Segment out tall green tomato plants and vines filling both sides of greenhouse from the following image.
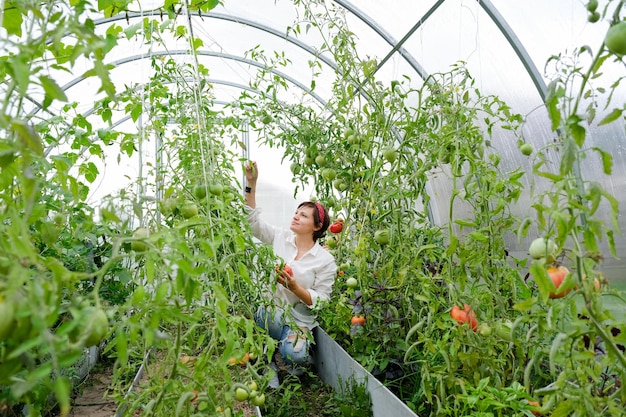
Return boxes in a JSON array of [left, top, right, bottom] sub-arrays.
[[0, 0, 626, 416]]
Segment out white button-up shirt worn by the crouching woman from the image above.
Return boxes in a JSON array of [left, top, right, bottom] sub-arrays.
[[245, 206, 337, 329]]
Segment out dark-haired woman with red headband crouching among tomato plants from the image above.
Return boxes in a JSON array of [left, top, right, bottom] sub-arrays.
[[245, 162, 337, 370]]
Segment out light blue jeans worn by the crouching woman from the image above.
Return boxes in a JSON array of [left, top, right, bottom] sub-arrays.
[[254, 306, 311, 364]]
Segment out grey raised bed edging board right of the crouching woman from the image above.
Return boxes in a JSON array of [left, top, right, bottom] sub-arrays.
[[313, 326, 418, 417]]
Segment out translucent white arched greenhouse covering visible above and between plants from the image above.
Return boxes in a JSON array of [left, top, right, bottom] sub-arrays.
[[3, 0, 626, 280]]
